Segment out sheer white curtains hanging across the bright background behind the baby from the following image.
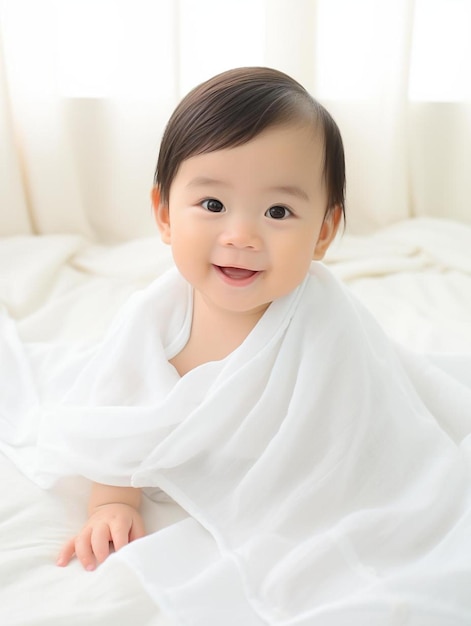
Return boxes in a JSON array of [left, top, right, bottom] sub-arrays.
[[0, 0, 471, 242]]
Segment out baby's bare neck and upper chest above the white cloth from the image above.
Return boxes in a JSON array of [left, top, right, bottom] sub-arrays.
[[171, 295, 264, 376]]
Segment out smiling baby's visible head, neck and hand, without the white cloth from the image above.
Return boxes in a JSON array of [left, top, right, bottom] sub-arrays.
[[57, 67, 345, 570]]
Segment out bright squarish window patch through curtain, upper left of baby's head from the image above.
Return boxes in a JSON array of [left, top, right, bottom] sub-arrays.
[[54, 0, 175, 99]]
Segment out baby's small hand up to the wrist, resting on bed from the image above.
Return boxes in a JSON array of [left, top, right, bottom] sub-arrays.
[[57, 502, 145, 571]]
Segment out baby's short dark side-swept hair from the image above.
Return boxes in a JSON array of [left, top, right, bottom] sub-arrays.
[[154, 67, 345, 217]]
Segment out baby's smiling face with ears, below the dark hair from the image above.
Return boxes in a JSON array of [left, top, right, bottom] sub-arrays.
[[159, 125, 338, 324]]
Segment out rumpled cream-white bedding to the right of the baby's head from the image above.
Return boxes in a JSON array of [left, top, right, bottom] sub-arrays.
[[328, 218, 471, 354]]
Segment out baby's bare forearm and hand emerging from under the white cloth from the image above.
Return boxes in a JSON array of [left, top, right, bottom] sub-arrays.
[[57, 483, 145, 571]]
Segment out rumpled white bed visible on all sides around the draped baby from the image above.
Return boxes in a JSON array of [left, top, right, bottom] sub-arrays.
[[0, 218, 471, 626]]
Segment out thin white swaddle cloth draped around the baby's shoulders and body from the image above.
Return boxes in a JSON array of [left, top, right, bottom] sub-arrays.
[[1, 263, 471, 626]]
